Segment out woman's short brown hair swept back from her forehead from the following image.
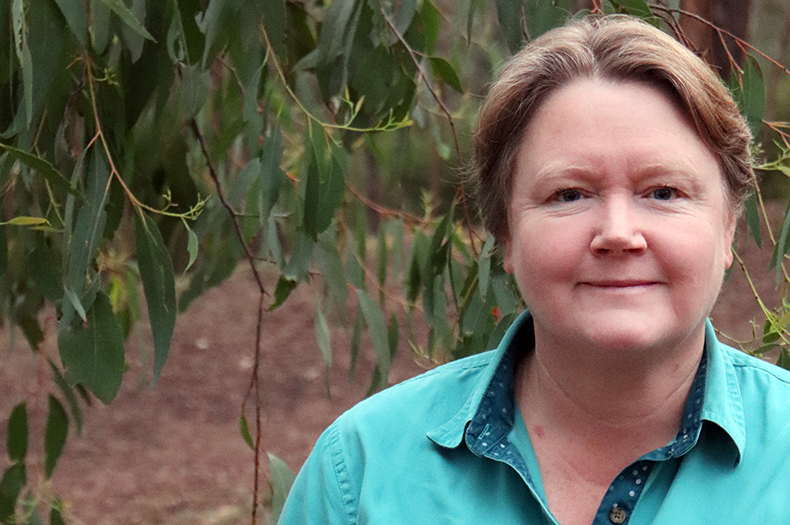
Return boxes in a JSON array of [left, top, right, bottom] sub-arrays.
[[471, 15, 755, 241]]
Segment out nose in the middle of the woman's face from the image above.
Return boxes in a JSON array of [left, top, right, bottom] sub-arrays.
[[590, 195, 647, 255]]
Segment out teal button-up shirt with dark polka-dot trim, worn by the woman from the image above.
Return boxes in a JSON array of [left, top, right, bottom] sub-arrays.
[[279, 313, 790, 525]]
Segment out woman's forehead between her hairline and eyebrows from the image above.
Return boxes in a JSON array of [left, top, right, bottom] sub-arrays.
[[516, 79, 723, 188]]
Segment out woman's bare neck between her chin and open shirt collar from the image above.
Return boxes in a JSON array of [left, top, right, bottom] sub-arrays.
[[516, 327, 705, 461]]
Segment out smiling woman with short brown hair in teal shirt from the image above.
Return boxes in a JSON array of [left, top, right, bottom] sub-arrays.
[[281, 17, 790, 525]]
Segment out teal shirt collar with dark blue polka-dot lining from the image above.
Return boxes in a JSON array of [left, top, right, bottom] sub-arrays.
[[428, 311, 746, 465]]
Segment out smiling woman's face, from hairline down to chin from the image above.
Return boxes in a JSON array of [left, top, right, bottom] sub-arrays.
[[505, 80, 735, 350]]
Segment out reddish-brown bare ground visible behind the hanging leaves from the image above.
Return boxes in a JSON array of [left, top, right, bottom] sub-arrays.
[[0, 205, 781, 525]]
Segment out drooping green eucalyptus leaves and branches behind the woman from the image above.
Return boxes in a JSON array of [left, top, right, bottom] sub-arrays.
[[0, 0, 790, 523]]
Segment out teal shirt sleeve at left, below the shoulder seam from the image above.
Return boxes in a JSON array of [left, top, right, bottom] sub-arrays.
[[278, 421, 357, 525]]
